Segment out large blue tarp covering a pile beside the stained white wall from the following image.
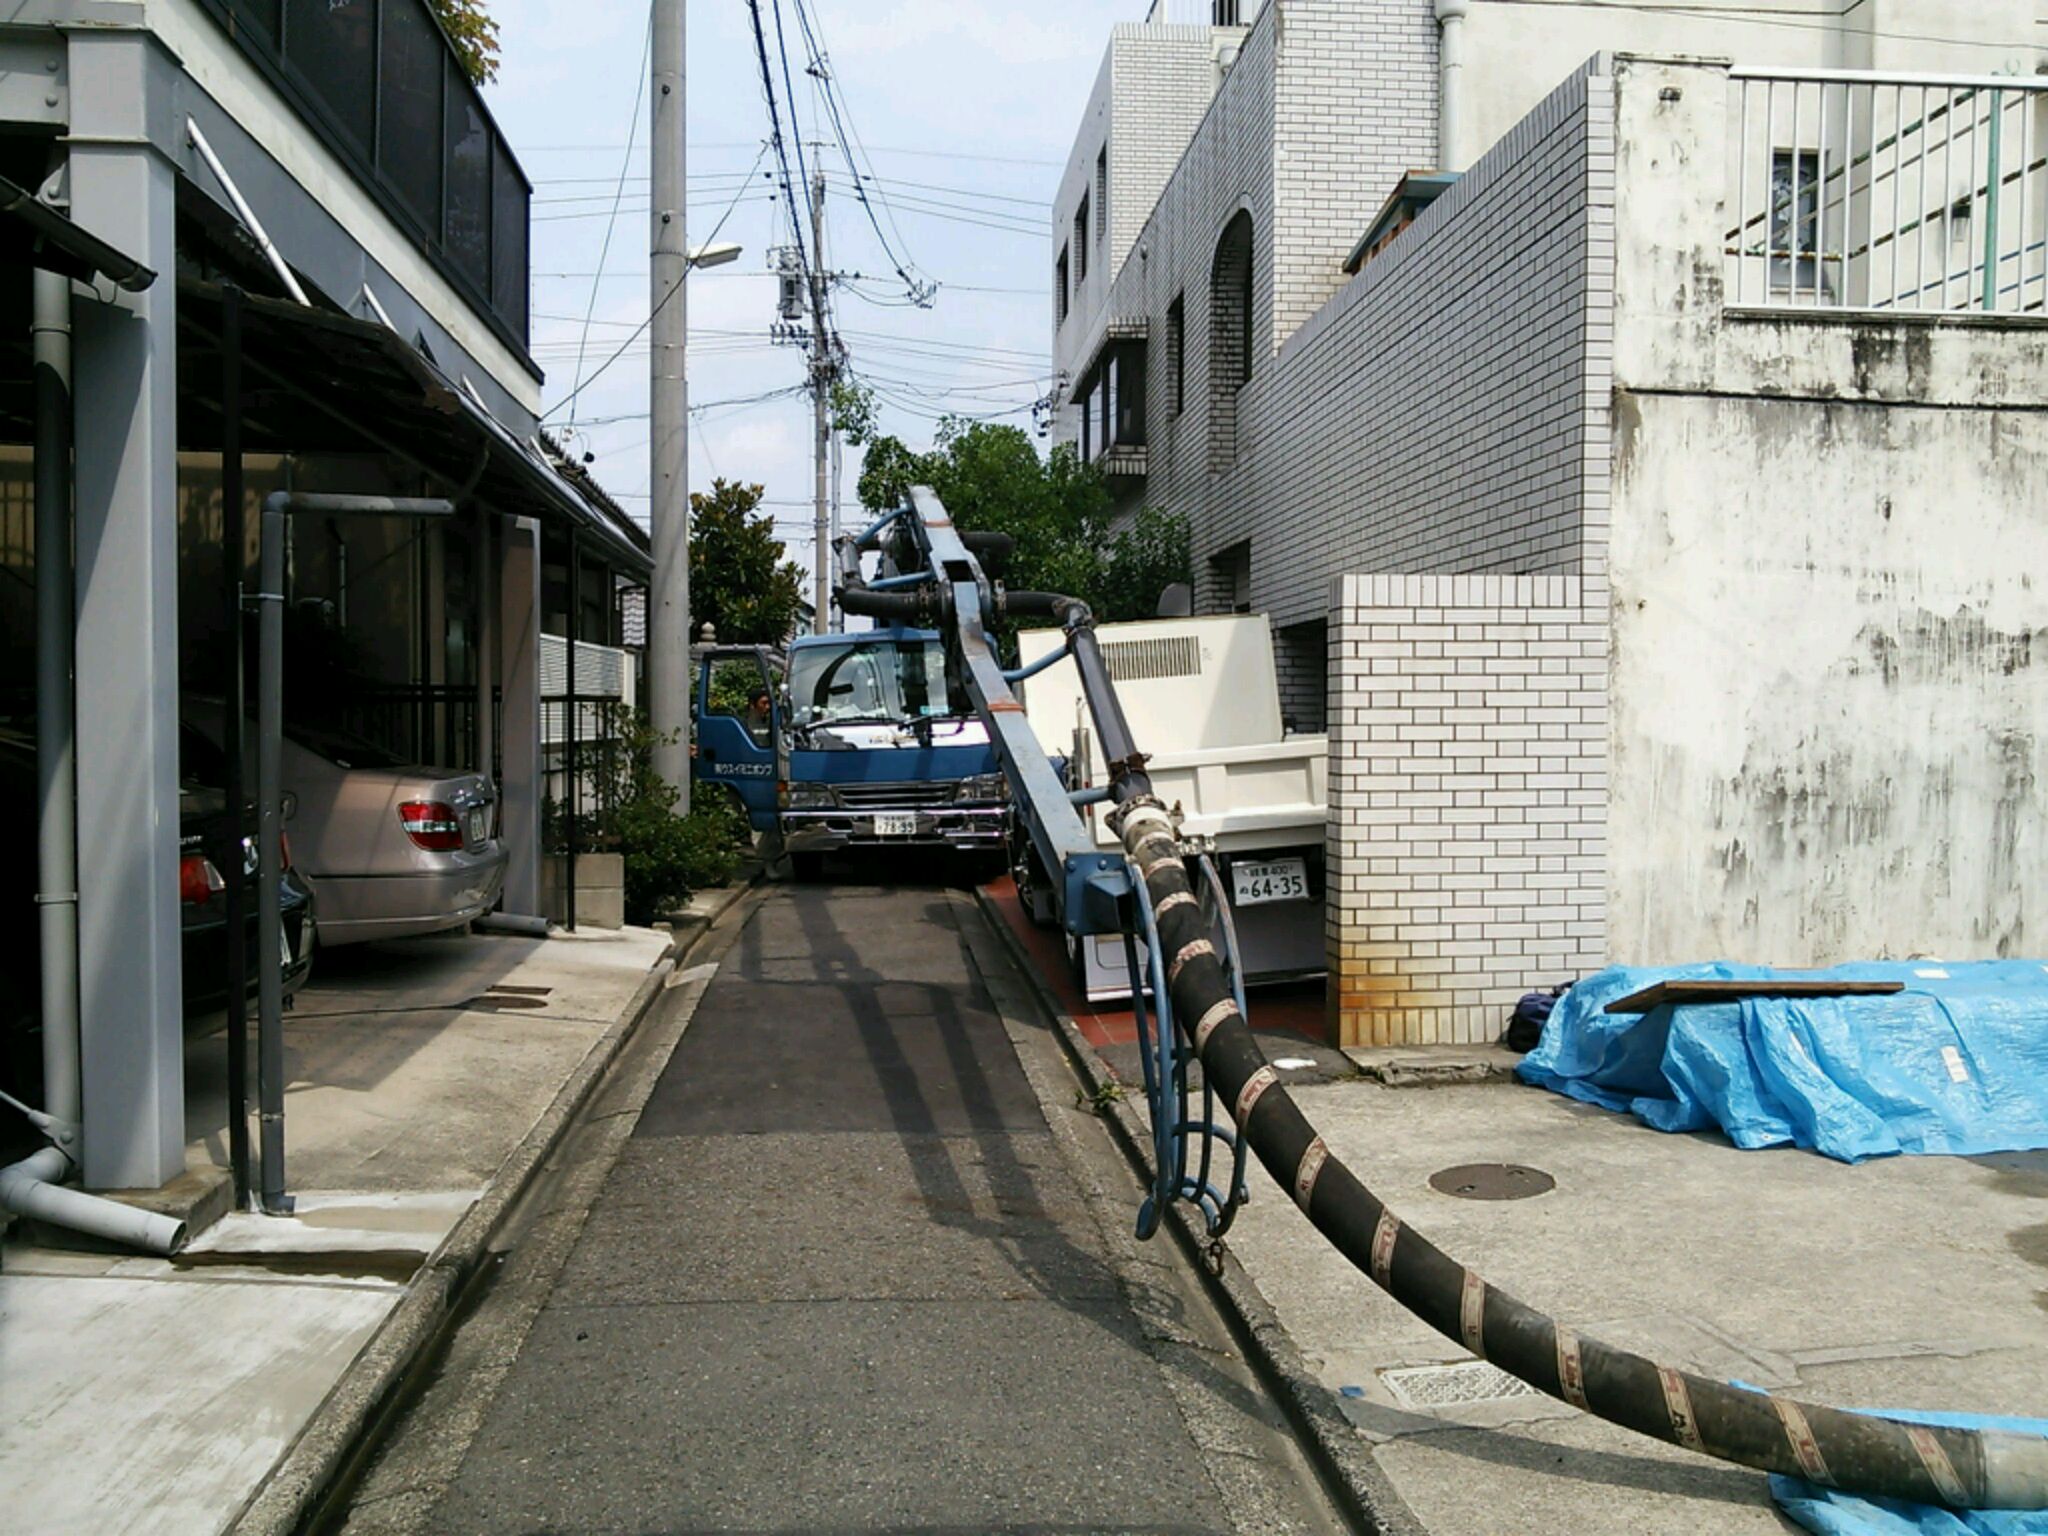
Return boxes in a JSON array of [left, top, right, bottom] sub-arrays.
[[1518, 961, 2048, 1163]]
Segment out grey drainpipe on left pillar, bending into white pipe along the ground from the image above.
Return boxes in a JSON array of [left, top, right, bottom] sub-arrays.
[[0, 268, 184, 1253]]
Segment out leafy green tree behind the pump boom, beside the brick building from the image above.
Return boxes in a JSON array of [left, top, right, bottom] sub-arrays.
[[858, 418, 1190, 623]]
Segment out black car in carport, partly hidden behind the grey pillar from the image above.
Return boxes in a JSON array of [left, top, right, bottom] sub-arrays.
[[0, 731, 315, 1102]]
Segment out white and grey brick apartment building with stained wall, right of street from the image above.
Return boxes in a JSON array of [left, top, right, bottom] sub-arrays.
[[1053, 0, 2048, 1040]]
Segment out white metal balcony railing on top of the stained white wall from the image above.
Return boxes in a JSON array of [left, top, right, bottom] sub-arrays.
[[1726, 70, 2048, 315]]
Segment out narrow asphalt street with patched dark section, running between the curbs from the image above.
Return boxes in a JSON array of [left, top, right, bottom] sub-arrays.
[[346, 885, 1343, 1532]]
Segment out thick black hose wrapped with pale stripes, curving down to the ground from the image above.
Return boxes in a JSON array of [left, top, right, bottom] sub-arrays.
[[1116, 793, 2048, 1509]]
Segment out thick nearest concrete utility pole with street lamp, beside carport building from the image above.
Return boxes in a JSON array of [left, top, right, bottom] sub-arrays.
[[647, 0, 690, 813]]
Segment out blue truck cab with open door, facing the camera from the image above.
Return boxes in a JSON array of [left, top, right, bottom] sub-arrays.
[[694, 627, 1010, 881]]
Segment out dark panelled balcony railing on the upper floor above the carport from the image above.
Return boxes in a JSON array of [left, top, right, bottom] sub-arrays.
[[201, 0, 532, 352]]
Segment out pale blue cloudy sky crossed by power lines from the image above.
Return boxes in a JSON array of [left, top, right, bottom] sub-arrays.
[[485, 0, 1147, 565]]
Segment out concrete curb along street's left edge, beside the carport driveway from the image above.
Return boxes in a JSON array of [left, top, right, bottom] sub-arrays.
[[227, 933, 684, 1536]]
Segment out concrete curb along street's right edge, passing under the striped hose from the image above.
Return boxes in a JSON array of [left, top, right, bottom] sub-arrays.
[[975, 887, 1427, 1536]]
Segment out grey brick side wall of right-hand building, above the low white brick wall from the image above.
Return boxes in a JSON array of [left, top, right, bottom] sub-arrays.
[[1063, 0, 1614, 629]]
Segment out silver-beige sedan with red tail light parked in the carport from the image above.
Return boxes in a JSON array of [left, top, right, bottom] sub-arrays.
[[184, 700, 506, 948]]
